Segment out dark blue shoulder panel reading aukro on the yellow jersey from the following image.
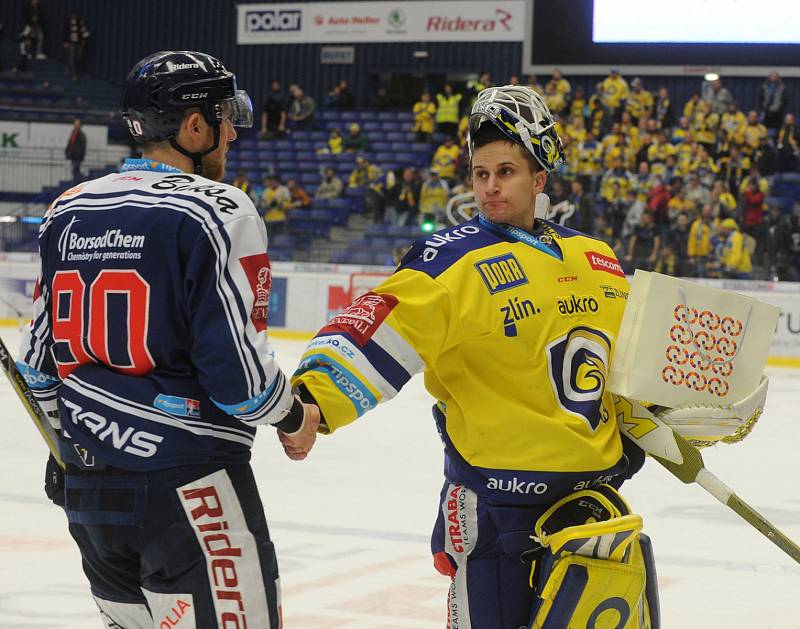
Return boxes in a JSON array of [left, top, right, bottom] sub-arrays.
[[398, 219, 510, 278]]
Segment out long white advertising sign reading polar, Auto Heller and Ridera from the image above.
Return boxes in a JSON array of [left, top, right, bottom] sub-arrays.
[[236, 0, 527, 44]]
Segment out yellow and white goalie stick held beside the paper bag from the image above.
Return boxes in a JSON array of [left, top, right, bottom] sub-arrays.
[[614, 395, 800, 563]]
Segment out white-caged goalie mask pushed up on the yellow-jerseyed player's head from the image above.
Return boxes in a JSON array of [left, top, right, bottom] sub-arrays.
[[467, 85, 565, 172]]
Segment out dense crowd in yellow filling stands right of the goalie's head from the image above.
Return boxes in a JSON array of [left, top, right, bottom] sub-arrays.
[[543, 70, 800, 280]]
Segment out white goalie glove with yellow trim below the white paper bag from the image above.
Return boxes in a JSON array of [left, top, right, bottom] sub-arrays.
[[650, 376, 769, 447]]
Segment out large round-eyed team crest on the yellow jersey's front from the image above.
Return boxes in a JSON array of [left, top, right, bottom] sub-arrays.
[[546, 326, 611, 430]]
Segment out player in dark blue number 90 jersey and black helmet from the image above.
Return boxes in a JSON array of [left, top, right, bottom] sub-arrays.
[[18, 52, 319, 629]]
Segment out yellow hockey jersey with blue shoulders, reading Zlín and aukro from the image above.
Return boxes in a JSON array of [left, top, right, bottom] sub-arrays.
[[292, 215, 628, 504]]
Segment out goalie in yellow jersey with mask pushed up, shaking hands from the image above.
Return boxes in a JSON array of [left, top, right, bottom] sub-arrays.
[[290, 86, 658, 629]]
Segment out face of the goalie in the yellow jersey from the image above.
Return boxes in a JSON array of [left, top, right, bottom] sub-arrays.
[[472, 141, 547, 229]]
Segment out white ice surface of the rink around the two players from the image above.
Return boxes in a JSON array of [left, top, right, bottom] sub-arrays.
[[0, 328, 800, 629]]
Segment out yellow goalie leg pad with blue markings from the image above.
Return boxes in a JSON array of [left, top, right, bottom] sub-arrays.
[[529, 485, 658, 629]]
